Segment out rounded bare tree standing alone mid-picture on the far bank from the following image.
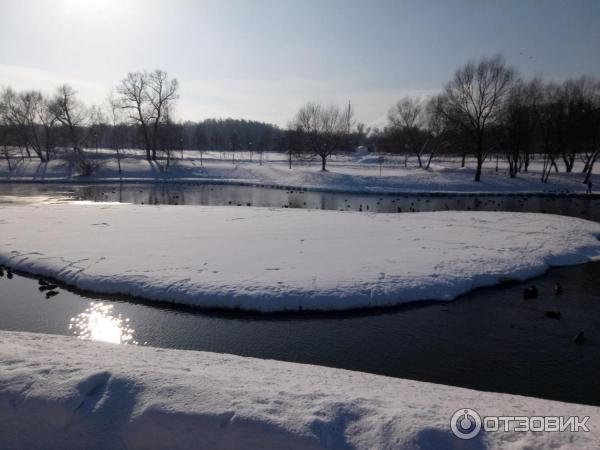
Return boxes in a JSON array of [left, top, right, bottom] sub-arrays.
[[290, 102, 353, 171]]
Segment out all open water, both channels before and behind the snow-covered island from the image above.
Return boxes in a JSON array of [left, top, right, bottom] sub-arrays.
[[0, 184, 600, 405]]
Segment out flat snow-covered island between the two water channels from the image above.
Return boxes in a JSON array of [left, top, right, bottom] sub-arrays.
[[0, 203, 600, 311]]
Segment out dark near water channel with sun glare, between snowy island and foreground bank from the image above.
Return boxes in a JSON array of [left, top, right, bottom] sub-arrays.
[[0, 263, 600, 405]]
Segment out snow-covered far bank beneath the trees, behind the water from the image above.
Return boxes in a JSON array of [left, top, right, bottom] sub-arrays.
[[0, 151, 600, 193]]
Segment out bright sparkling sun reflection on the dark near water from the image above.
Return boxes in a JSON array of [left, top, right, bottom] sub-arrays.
[[69, 302, 137, 344]]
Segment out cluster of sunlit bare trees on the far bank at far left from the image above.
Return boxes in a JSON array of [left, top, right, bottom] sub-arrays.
[[0, 70, 178, 172]]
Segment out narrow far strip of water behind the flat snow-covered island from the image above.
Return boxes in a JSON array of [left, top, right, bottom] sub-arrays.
[[0, 183, 600, 221]]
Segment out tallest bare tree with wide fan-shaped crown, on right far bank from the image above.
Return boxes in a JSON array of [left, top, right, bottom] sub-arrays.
[[444, 55, 515, 181]]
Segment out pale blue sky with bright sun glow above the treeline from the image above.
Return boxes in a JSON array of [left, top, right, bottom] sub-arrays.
[[0, 0, 600, 126]]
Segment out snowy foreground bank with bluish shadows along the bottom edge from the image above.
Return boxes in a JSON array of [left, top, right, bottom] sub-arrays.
[[0, 332, 600, 450]]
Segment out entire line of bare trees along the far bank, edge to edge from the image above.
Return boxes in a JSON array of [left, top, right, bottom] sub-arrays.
[[0, 56, 600, 182]]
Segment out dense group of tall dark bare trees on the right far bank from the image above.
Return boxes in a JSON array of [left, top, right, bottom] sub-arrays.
[[372, 56, 600, 182]]
